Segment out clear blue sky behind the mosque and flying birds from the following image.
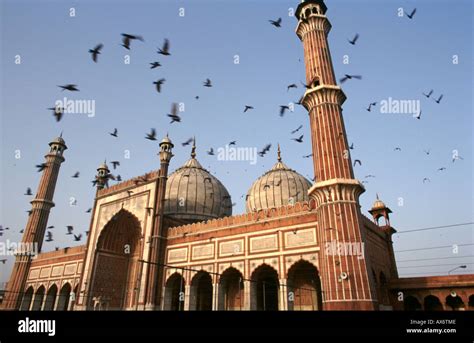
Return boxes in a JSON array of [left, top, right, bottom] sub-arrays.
[[0, 0, 474, 282]]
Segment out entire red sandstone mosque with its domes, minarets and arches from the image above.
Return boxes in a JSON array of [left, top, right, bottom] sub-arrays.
[[2, 0, 474, 310]]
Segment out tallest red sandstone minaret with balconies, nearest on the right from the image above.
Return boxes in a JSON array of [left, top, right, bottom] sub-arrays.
[[295, 0, 376, 310]]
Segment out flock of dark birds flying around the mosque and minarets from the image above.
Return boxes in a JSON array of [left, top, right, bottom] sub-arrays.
[[0, 8, 462, 255]]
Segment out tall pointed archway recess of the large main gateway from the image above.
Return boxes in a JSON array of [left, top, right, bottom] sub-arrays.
[[89, 209, 141, 310]]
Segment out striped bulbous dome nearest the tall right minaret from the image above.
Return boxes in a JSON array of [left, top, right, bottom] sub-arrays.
[[246, 146, 311, 212]]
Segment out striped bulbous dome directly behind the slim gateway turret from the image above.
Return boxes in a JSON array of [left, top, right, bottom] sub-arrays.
[[164, 143, 232, 222]]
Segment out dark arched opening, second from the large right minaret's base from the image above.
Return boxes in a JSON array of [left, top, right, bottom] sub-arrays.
[[250, 264, 279, 311]]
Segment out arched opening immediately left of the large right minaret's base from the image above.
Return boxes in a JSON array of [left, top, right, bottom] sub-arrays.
[[287, 260, 322, 311]]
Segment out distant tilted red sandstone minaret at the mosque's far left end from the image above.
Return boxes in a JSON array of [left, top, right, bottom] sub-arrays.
[[4, 136, 67, 310]]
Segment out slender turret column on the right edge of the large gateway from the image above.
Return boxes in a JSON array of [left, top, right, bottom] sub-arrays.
[[145, 135, 174, 310]]
